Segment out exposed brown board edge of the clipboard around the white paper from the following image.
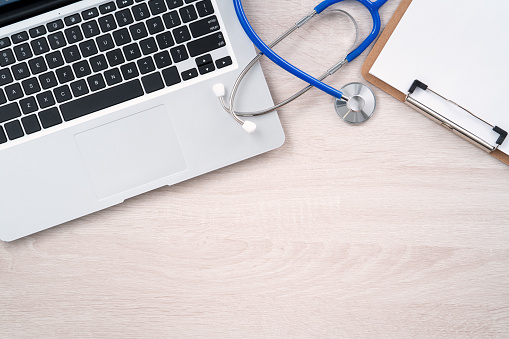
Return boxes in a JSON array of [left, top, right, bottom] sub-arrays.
[[361, 0, 509, 165]]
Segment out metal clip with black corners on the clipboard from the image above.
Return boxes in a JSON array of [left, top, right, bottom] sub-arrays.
[[405, 80, 507, 153]]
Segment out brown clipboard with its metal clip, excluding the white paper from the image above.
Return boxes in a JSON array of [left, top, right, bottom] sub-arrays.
[[361, 0, 509, 165]]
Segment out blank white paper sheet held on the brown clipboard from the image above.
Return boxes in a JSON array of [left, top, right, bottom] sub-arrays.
[[370, 0, 509, 154]]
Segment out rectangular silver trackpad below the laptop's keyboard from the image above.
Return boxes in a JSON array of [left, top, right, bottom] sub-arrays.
[[75, 105, 187, 199]]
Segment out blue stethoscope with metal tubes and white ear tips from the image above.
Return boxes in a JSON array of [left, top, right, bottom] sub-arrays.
[[213, 0, 387, 133]]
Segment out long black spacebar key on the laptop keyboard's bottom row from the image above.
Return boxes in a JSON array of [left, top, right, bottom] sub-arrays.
[[60, 79, 143, 121]]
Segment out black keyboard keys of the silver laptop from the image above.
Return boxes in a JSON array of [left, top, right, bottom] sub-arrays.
[[0, 0, 232, 144]]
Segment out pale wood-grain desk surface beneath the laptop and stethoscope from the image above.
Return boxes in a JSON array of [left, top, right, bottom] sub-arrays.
[[0, 0, 509, 338]]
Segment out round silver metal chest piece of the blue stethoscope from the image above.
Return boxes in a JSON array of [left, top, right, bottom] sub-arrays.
[[334, 82, 376, 125]]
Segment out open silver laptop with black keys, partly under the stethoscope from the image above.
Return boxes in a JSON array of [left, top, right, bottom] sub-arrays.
[[0, 0, 284, 241]]
